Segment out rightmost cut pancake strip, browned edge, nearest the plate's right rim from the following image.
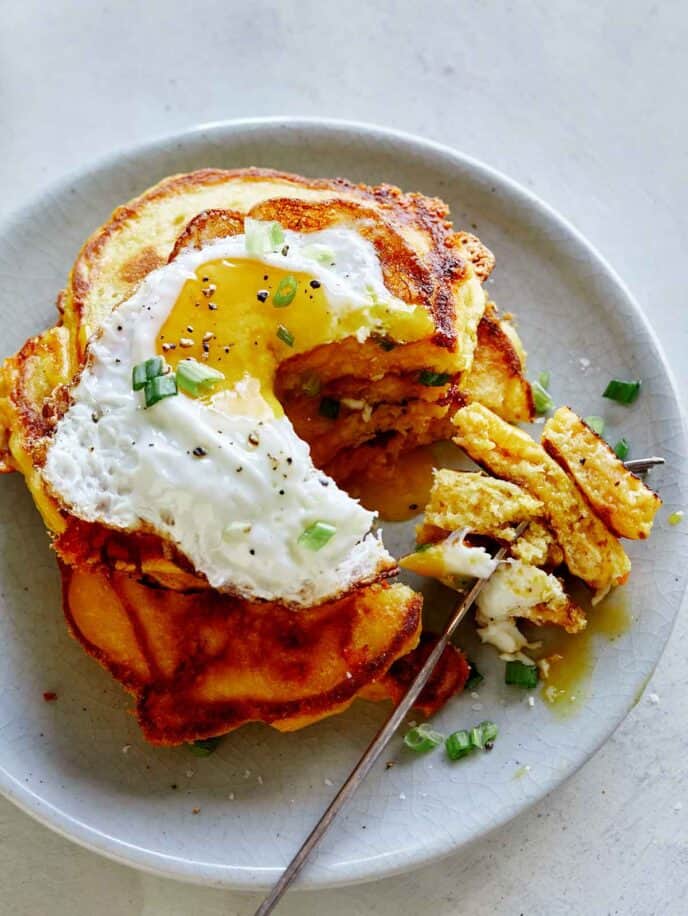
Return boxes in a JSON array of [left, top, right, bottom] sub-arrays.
[[542, 407, 662, 539]]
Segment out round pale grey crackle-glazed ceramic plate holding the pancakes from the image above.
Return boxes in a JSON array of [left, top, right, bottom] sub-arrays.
[[0, 119, 688, 888]]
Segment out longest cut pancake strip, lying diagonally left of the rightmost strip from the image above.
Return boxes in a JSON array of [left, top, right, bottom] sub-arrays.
[[452, 404, 631, 592]]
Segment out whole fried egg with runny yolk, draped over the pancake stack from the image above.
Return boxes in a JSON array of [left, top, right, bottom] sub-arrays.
[[42, 220, 431, 607]]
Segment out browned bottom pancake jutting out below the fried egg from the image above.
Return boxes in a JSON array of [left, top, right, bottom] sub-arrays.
[[62, 567, 430, 744]]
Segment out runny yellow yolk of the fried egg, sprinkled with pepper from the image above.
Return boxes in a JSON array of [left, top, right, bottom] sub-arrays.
[[157, 258, 432, 417]]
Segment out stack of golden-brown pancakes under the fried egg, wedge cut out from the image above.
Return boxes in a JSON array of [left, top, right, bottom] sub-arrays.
[[0, 169, 533, 744]]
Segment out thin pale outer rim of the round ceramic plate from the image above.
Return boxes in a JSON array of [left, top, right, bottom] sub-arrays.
[[0, 115, 688, 891]]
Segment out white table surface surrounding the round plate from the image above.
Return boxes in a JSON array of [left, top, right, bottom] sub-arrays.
[[0, 0, 688, 916]]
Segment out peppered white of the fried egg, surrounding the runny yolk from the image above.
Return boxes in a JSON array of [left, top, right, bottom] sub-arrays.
[[43, 228, 412, 607]]
